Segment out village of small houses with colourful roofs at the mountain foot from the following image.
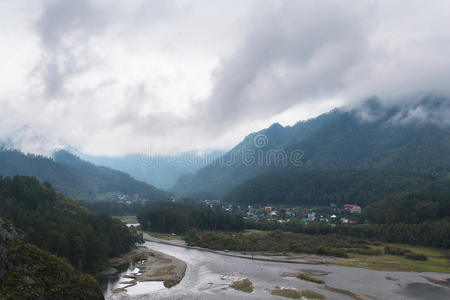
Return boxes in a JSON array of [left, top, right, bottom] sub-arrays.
[[204, 200, 364, 225]]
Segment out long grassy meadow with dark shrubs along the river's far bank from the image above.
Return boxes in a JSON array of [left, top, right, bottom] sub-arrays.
[[184, 231, 450, 273]]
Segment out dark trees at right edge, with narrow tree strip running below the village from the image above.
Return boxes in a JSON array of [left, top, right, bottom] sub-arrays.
[[245, 192, 450, 248]]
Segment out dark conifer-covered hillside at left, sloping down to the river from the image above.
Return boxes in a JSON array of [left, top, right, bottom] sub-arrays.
[[0, 176, 143, 273]]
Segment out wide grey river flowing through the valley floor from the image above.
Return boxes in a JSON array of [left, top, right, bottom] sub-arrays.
[[105, 242, 450, 300]]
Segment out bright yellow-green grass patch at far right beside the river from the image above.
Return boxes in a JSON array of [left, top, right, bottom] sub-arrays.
[[337, 243, 450, 273]]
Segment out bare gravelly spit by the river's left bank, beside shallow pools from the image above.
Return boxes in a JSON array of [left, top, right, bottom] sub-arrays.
[[109, 246, 186, 292]]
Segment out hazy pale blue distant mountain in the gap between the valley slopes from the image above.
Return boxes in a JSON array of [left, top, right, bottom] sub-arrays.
[[80, 150, 225, 189]]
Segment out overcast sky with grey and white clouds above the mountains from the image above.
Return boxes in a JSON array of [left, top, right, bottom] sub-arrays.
[[0, 0, 450, 155]]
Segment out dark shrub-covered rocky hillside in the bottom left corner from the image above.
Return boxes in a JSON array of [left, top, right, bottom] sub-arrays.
[[0, 217, 104, 300]]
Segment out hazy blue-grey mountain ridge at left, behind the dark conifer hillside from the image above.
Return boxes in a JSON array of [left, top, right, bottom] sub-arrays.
[[0, 149, 169, 201]]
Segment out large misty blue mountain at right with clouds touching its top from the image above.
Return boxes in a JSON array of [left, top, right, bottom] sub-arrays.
[[173, 95, 450, 197]]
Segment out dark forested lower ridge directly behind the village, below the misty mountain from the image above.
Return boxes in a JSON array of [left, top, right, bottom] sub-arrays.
[[225, 170, 450, 206]]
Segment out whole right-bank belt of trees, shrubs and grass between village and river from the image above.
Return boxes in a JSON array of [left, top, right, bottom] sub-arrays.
[[137, 193, 450, 273]]
